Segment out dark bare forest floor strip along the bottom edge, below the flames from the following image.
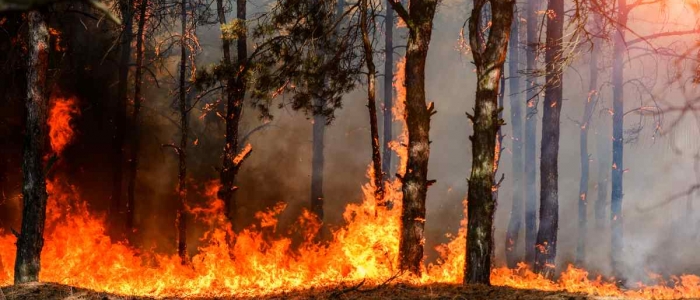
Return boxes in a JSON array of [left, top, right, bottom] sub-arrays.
[[0, 283, 610, 300]]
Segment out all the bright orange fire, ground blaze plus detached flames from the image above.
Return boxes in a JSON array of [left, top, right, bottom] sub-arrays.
[[0, 89, 700, 299]]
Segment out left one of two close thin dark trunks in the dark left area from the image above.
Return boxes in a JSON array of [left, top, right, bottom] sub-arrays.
[[110, 0, 134, 228]]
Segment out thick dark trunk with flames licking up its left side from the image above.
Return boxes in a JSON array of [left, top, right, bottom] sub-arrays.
[[390, 0, 438, 275]]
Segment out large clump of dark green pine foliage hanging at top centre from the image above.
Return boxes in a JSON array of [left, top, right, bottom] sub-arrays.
[[250, 0, 364, 123]]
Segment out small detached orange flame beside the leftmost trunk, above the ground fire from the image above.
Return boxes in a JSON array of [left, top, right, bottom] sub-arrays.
[[48, 98, 80, 155]]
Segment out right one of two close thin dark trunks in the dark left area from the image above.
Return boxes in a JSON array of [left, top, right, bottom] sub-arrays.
[[126, 0, 148, 236]]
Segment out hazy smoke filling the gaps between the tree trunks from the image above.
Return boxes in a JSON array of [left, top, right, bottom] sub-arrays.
[[0, 0, 700, 280]]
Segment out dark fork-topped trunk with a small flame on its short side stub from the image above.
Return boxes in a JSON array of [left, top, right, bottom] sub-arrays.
[[216, 0, 248, 227]]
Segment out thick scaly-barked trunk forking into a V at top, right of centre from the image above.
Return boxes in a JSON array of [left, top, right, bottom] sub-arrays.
[[464, 0, 515, 284]]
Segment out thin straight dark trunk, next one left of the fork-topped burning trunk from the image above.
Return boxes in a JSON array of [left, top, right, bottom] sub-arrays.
[[175, 0, 189, 263]]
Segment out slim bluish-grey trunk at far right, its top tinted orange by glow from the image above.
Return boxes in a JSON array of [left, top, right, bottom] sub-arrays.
[[610, 0, 628, 278]]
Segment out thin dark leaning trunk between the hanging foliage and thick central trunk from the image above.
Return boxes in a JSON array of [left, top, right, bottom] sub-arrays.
[[360, 0, 384, 203]]
